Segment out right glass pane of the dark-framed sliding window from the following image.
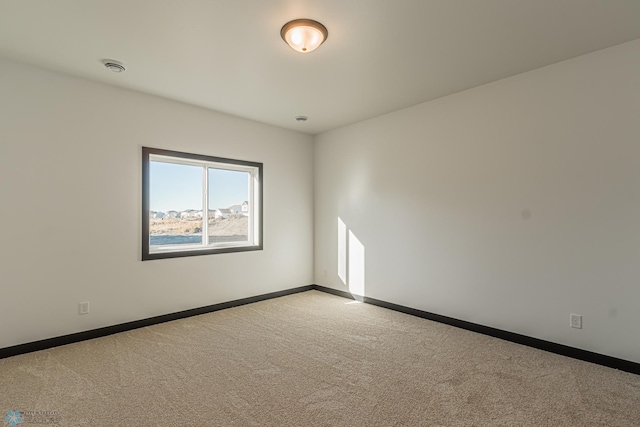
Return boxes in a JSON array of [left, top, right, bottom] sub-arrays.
[[208, 168, 251, 244]]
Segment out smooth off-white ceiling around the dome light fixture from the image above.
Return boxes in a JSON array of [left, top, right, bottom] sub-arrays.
[[0, 0, 640, 134]]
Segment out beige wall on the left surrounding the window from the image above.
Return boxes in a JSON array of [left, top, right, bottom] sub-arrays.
[[0, 61, 313, 348]]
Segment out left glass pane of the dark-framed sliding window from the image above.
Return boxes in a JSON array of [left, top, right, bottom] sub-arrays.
[[149, 161, 203, 250]]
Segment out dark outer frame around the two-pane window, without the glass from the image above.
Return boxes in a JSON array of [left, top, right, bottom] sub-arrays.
[[142, 147, 264, 261]]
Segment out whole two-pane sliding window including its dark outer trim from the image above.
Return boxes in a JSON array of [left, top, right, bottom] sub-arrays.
[[142, 147, 262, 261]]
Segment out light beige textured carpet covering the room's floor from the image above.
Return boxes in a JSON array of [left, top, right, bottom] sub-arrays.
[[0, 291, 640, 427]]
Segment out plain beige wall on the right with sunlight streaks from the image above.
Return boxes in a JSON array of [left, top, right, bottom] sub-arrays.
[[314, 41, 640, 362]]
